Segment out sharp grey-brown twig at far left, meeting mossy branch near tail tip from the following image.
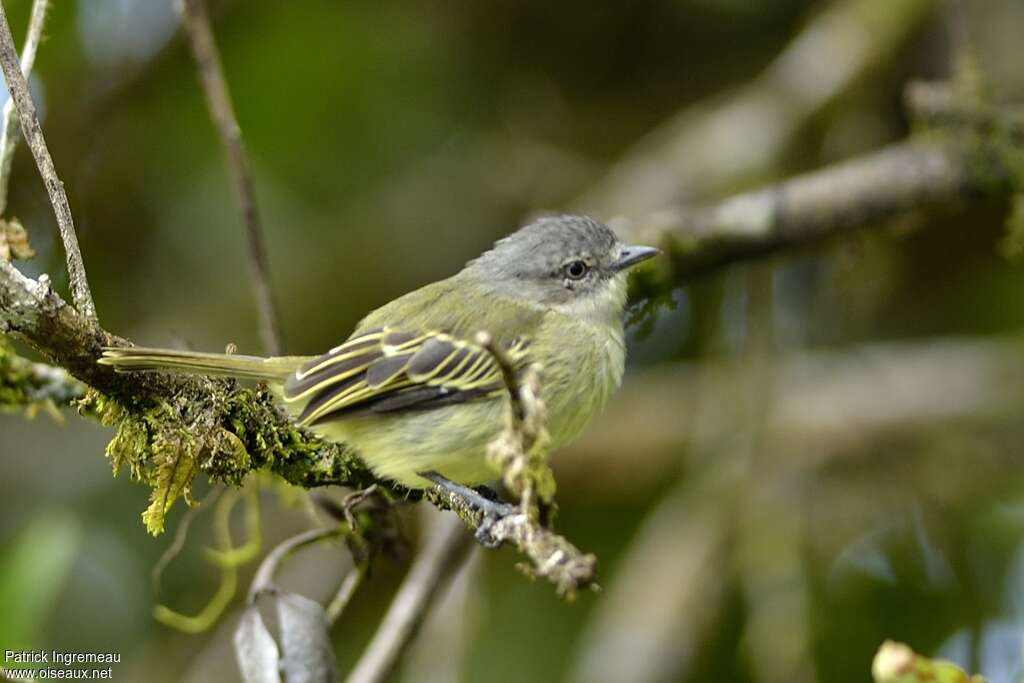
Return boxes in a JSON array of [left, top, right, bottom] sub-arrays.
[[0, 4, 96, 324]]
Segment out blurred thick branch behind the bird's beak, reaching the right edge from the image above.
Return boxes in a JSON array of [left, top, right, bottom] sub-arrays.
[[623, 109, 1024, 283]]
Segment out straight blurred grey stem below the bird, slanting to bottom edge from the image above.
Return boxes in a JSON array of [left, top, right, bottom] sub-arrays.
[[346, 516, 473, 683]]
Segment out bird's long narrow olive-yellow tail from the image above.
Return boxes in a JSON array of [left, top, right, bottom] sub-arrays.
[[97, 346, 308, 382]]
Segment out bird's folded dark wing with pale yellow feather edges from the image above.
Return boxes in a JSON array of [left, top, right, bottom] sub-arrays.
[[284, 328, 528, 426]]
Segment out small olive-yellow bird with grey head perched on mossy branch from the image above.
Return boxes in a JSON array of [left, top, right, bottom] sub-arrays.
[[99, 215, 658, 488]]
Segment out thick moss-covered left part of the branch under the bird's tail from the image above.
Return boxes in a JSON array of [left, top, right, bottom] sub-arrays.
[[0, 255, 376, 533]]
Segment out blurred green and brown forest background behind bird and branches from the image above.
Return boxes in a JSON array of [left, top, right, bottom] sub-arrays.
[[0, 0, 1024, 683]]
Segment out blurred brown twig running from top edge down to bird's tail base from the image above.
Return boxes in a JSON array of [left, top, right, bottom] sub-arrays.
[[180, 0, 285, 355]]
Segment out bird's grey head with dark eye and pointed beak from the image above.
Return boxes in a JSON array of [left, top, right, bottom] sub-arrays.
[[464, 215, 657, 319]]
